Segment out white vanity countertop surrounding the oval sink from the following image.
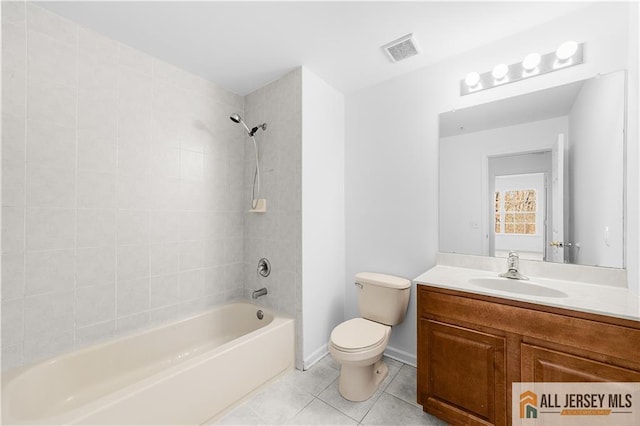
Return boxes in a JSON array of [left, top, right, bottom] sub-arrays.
[[413, 265, 640, 321]]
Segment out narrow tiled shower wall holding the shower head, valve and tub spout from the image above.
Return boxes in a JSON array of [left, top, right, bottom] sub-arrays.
[[243, 68, 302, 368]]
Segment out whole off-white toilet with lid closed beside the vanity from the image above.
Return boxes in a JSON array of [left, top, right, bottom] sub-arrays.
[[329, 272, 411, 401]]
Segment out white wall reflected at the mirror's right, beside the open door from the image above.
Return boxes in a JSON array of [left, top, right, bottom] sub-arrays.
[[565, 72, 625, 268]]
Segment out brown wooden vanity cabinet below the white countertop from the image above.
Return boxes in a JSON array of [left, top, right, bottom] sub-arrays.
[[417, 285, 640, 425]]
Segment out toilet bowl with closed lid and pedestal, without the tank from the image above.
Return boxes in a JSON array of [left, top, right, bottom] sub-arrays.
[[329, 318, 391, 401]]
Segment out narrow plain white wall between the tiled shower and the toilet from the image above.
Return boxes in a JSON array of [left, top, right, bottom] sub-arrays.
[[302, 68, 345, 369]]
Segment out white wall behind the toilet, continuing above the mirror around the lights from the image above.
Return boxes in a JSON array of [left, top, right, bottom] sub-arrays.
[[345, 3, 640, 361]]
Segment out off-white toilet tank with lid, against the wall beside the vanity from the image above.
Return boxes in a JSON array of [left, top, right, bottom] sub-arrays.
[[355, 272, 411, 325]]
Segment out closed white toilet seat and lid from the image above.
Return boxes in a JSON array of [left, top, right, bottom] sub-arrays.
[[331, 318, 390, 353]]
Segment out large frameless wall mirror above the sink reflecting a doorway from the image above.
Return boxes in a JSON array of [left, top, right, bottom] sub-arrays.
[[439, 71, 626, 268]]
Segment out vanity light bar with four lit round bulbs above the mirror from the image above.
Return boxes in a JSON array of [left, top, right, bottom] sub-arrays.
[[460, 41, 584, 96]]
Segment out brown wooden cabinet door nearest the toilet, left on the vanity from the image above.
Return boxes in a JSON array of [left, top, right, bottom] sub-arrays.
[[419, 318, 506, 425]]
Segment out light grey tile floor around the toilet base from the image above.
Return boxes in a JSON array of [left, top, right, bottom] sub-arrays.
[[214, 355, 446, 425]]
